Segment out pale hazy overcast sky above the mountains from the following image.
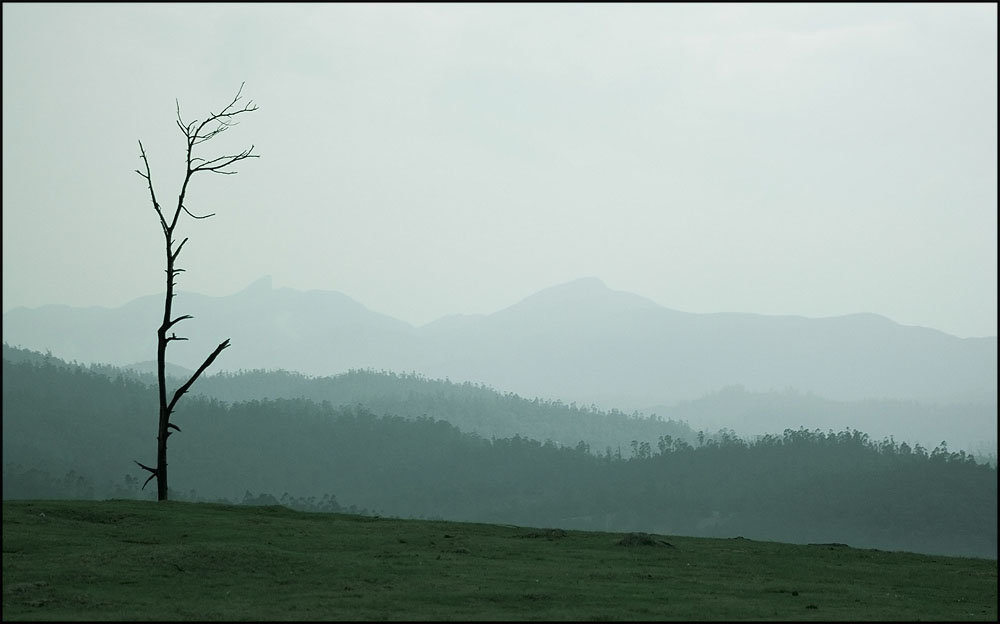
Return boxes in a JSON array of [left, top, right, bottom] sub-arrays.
[[3, 3, 997, 337]]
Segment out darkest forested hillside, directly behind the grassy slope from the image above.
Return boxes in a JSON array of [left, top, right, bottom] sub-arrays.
[[3, 346, 997, 558]]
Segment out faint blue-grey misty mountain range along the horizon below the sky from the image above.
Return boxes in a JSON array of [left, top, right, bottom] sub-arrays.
[[3, 278, 997, 409]]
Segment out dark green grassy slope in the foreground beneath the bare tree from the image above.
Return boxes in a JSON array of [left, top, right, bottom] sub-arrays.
[[3, 501, 997, 621]]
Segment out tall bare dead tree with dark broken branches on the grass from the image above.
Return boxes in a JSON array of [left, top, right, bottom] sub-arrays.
[[135, 84, 258, 500]]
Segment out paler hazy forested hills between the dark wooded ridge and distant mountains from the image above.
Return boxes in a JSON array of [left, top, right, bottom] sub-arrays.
[[186, 370, 997, 462]]
